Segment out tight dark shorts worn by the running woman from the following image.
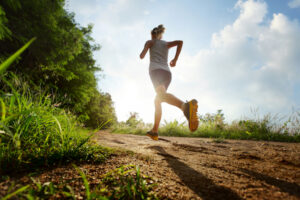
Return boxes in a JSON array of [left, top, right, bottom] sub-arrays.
[[150, 69, 172, 90]]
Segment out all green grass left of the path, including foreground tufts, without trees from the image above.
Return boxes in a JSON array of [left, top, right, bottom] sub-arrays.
[[0, 39, 161, 200]]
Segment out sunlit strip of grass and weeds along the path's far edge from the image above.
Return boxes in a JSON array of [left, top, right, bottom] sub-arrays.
[[112, 110, 300, 142]]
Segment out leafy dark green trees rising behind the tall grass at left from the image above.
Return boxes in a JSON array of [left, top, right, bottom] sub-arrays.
[[0, 0, 116, 127]]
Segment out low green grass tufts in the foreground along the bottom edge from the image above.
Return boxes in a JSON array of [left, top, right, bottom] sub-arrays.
[[2, 165, 158, 200]]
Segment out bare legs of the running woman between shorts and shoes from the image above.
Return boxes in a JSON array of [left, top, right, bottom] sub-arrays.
[[152, 85, 184, 133]]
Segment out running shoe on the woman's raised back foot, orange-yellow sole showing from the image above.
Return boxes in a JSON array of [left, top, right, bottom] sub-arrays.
[[183, 99, 199, 132]]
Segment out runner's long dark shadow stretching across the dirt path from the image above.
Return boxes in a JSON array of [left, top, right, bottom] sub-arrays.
[[149, 146, 242, 199]]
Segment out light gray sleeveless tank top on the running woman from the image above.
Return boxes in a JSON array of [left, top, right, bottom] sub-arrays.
[[149, 40, 170, 72]]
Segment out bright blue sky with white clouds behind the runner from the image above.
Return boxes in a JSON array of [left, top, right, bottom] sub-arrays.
[[65, 0, 300, 122]]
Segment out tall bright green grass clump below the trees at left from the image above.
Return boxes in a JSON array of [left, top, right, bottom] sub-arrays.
[[0, 78, 110, 173]]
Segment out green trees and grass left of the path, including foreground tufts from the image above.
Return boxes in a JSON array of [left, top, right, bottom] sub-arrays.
[[0, 0, 156, 199]]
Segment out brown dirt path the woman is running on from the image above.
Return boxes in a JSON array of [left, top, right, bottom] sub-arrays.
[[95, 132, 300, 199]]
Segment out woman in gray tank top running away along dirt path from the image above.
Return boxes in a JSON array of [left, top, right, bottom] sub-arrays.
[[140, 25, 199, 140]]
